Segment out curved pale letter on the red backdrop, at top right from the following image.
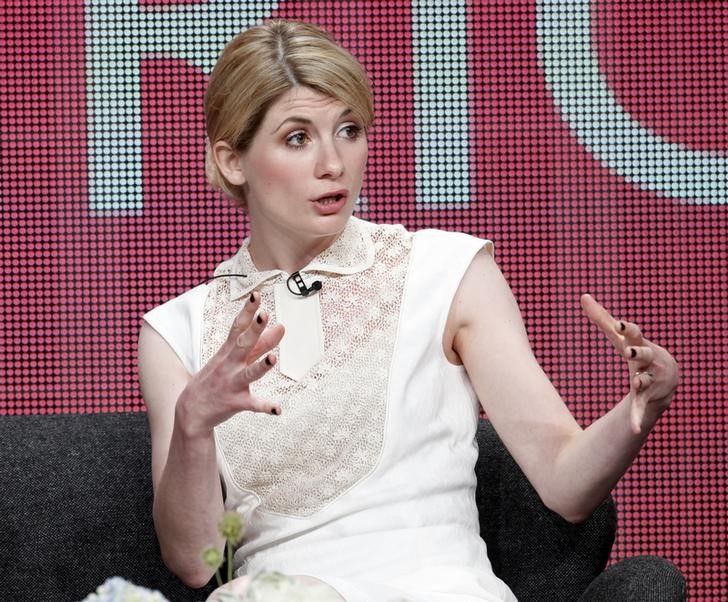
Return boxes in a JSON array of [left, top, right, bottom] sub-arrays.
[[536, 0, 728, 204]]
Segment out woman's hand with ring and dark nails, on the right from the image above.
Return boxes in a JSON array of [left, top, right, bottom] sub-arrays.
[[581, 295, 678, 434]]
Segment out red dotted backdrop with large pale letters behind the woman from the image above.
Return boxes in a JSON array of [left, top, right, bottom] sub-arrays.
[[0, 0, 728, 600]]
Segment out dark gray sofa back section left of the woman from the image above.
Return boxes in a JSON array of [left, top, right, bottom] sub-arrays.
[[0, 412, 212, 602]]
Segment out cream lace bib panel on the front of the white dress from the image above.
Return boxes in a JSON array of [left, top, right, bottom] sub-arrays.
[[202, 218, 412, 516]]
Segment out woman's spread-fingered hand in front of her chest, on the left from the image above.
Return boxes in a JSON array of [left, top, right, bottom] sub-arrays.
[[176, 292, 284, 436]]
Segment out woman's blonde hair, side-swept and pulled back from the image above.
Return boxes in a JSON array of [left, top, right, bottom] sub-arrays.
[[205, 20, 374, 208]]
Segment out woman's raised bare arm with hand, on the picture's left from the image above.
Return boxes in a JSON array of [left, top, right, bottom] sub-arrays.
[[139, 295, 283, 587]]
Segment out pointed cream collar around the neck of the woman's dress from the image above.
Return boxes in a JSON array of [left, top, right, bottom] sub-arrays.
[[215, 217, 374, 301]]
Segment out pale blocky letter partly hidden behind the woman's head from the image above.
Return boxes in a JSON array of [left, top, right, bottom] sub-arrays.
[[85, 0, 278, 213]]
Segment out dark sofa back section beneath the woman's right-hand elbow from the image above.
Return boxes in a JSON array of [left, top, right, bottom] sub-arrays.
[[476, 421, 617, 602]]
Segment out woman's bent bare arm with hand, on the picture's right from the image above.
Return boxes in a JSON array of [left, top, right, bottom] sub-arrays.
[[444, 252, 677, 522]]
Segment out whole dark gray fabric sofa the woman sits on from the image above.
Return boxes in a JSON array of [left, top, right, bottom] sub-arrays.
[[0, 412, 685, 602]]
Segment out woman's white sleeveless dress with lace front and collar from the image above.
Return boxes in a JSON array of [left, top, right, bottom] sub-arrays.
[[144, 218, 515, 602]]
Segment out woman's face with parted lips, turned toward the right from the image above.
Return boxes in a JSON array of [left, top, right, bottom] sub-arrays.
[[238, 87, 368, 253]]
